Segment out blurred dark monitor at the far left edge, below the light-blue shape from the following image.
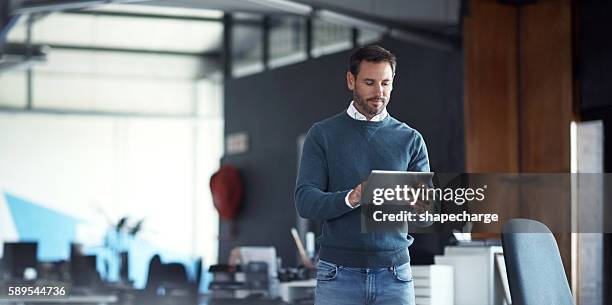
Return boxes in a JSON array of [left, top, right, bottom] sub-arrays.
[[2, 242, 38, 279]]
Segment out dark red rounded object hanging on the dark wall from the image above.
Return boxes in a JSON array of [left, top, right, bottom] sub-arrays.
[[210, 165, 244, 220]]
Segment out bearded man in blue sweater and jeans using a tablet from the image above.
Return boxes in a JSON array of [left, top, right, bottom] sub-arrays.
[[295, 46, 429, 305]]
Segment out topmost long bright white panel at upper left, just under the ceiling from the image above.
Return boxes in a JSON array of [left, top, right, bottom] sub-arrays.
[[8, 13, 223, 52]]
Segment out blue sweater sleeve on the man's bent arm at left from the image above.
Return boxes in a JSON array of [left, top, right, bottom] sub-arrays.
[[295, 125, 353, 221]]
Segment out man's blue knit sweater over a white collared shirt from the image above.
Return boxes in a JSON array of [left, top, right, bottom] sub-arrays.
[[295, 111, 429, 268]]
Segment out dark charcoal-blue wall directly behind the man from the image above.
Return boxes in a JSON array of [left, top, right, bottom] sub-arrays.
[[219, 39, 464, 265]]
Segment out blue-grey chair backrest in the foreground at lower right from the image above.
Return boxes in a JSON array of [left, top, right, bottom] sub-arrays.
[[502, 218, 574, 305]]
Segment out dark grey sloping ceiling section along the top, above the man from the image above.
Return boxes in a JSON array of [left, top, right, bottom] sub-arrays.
[[146, 0, 461, 50]]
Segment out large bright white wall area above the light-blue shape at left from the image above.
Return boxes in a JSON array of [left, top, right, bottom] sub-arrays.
[[0, 109, 222, 262]]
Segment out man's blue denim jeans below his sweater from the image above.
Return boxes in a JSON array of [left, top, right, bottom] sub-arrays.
[[315, 261, 414, 305]]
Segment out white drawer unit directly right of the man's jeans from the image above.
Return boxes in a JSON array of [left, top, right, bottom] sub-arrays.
[[411, 265, 454, 305]]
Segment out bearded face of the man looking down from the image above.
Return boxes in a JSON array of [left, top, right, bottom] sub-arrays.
[[346, 61, 393, 120]]
